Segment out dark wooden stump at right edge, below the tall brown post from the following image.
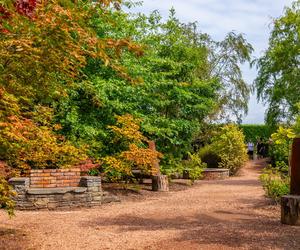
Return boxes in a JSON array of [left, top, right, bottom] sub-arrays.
[[281, 195, 300, 226]]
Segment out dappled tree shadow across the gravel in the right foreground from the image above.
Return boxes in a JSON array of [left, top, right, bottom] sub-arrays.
[[82, 211, 300, 249]]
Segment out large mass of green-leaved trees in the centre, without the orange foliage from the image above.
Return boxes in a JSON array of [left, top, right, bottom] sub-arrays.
[[57, 7, 251, 165]]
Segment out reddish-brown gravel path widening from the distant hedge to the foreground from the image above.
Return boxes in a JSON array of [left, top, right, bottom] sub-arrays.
[[0, 161, 300, 250]]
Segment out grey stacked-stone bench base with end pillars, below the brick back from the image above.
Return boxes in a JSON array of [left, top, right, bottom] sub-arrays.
[[9, 176, 120, 210]]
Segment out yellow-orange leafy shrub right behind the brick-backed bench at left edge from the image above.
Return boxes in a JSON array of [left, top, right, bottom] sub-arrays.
[[0, 112, 87, 169]]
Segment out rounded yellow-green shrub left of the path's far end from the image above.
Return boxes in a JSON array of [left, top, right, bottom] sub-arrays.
[[210, 124, 248, 175]]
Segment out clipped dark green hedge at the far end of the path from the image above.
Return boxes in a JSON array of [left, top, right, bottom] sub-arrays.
[[239, 124, 273, 143]]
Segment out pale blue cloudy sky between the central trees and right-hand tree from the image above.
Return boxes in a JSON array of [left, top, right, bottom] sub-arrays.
[[130, 0, 292, 124]]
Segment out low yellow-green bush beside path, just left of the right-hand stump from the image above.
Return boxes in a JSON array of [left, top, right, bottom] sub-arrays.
[[260, 168, 290, 202]]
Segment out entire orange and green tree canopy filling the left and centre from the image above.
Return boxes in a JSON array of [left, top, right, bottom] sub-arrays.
[[0, 0, 253, 215]]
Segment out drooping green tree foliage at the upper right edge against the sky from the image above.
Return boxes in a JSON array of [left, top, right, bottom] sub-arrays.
[[255, 0, 300, 125]]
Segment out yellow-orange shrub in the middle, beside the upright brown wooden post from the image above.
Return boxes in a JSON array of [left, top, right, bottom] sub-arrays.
[[101, 114, 162, 181]]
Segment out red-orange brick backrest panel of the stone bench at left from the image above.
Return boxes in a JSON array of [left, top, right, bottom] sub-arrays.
[[30, 168, 80, 188]]
